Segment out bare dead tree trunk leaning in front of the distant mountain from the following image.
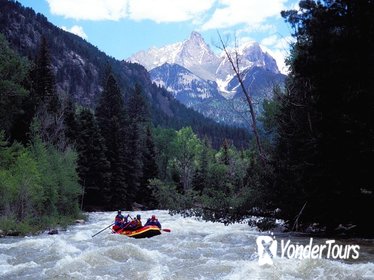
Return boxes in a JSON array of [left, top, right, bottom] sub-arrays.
[[217, 31, 265, 161]]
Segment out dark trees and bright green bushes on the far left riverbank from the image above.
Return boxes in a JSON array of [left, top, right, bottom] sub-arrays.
[[0, 34, 82, 234]]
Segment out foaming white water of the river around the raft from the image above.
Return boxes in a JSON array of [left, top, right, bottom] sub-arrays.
[[0, 211, 374, 280]]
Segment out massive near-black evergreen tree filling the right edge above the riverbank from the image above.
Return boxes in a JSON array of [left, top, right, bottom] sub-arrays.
[[274, 0, 374, 232]]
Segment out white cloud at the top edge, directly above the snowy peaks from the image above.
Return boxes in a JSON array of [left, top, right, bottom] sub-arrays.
[[202, 0, 287, 30]]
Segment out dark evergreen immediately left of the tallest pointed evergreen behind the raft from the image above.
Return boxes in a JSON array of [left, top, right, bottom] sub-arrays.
[[76, 109, 110, 210]]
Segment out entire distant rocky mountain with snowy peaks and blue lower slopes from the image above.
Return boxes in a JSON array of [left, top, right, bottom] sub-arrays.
[[127, 32, 285, 126]]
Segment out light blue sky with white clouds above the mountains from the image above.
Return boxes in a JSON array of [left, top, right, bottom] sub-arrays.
[[18, 0, 299, 73]]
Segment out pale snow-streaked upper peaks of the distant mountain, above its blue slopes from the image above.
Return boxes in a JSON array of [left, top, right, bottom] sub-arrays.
[[128, 31, 279, 85]]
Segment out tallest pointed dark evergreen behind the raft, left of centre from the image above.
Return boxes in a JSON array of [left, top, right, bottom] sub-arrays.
[[96, 74, 129, 209]]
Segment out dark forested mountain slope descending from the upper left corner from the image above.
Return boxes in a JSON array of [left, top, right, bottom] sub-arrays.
[[0, 0, 248, 147]]
